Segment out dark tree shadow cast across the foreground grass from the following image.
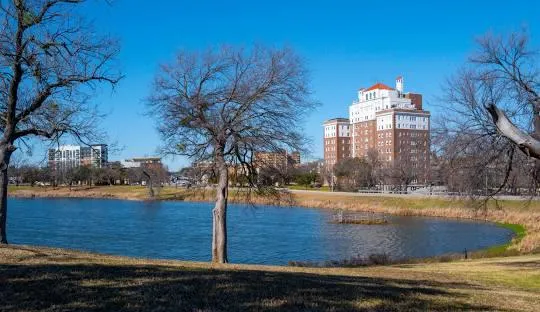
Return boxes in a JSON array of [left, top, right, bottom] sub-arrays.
[[0, 264, 490, 312]]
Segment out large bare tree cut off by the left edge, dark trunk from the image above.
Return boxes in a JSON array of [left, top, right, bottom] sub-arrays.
[[0, 0, 120, 244]]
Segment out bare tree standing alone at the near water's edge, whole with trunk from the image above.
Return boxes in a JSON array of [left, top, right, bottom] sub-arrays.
[[148, 46, 314, 263]]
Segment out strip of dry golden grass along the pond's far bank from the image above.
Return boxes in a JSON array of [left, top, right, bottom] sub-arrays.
[[9, 186, 540, 256]]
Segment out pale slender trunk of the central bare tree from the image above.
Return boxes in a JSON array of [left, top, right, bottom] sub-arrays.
[[212, 156, 229, 263]]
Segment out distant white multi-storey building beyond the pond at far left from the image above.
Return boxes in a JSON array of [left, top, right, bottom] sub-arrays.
[[48, 144, 109, 170]]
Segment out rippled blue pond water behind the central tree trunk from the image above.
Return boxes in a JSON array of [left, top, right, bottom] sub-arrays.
[[8, 199, 512, 265]]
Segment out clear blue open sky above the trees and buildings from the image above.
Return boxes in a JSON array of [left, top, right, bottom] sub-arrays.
[[38, 0, 540, 169]]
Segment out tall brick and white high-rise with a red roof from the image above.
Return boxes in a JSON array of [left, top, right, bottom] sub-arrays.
[[324, 77, 430, 183]]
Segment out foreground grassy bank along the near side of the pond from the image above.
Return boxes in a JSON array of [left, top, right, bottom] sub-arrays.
[[0, 246, 540, 312]]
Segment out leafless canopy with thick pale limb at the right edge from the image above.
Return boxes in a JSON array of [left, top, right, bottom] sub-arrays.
[[434, 33, 540, 194]]
